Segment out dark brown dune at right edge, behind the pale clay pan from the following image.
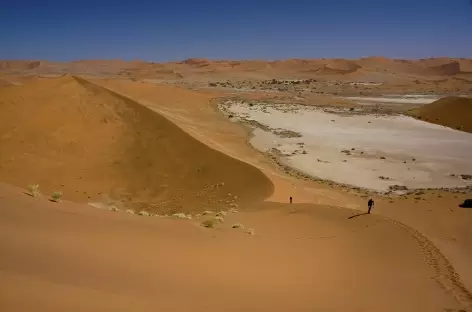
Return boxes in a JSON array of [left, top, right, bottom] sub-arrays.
[[412, 97, 472, 133]]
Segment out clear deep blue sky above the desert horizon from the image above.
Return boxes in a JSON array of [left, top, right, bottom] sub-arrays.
[[0, 0, 472, 61]]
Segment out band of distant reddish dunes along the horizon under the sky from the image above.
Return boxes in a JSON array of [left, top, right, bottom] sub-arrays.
[[0, 57, 472, 80]]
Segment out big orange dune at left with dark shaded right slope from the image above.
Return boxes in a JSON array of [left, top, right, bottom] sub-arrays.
[[0, 76, 273, 212]]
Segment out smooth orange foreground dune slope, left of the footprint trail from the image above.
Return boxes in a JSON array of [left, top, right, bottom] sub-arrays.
[[0, 185, 464, 312]]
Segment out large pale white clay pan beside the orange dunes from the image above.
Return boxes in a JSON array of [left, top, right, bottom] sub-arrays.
[[223, 102, 472, 192]]
